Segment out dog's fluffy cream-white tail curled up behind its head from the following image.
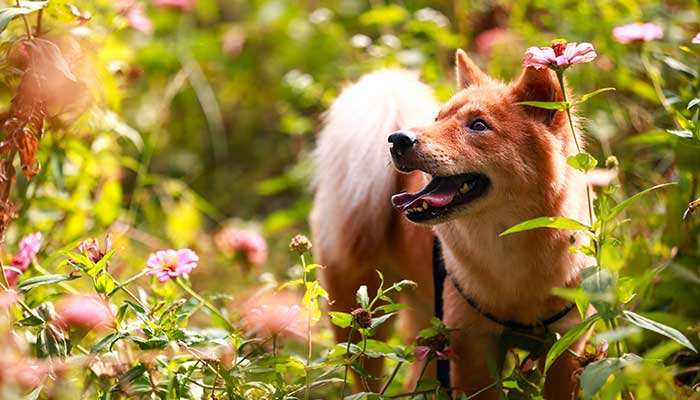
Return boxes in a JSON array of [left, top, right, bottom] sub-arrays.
[[311, 70, 438, 263]]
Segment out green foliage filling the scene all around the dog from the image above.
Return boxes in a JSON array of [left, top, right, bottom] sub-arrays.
[[0, 0, 700, 399]]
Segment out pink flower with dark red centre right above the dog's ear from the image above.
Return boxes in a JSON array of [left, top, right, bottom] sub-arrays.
[[523, 39, 598, 70]]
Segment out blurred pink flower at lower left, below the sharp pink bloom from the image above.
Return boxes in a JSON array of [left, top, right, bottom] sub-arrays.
[[56, 295, 114, 330]]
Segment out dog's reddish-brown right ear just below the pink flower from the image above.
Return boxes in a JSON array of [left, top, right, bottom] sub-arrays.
[[511, 67, 566, 126]]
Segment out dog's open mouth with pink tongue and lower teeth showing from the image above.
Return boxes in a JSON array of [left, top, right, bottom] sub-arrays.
[[391, 173, 491, 222]]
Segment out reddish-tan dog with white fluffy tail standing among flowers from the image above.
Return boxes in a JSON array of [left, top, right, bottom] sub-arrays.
[[311, 50, 590, 399]]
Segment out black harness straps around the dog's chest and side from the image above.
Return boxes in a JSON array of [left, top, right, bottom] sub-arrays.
[[433, 237, 575, 389]]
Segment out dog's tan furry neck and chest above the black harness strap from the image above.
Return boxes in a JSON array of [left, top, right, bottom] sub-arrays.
[[435, 166, 589, 315]]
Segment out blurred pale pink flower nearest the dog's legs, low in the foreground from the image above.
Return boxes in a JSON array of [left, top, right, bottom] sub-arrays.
[[242, 293, 308, 337]]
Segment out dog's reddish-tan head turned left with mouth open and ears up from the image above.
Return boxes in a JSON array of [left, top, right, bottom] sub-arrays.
[[389, 50, 573, 224]]
